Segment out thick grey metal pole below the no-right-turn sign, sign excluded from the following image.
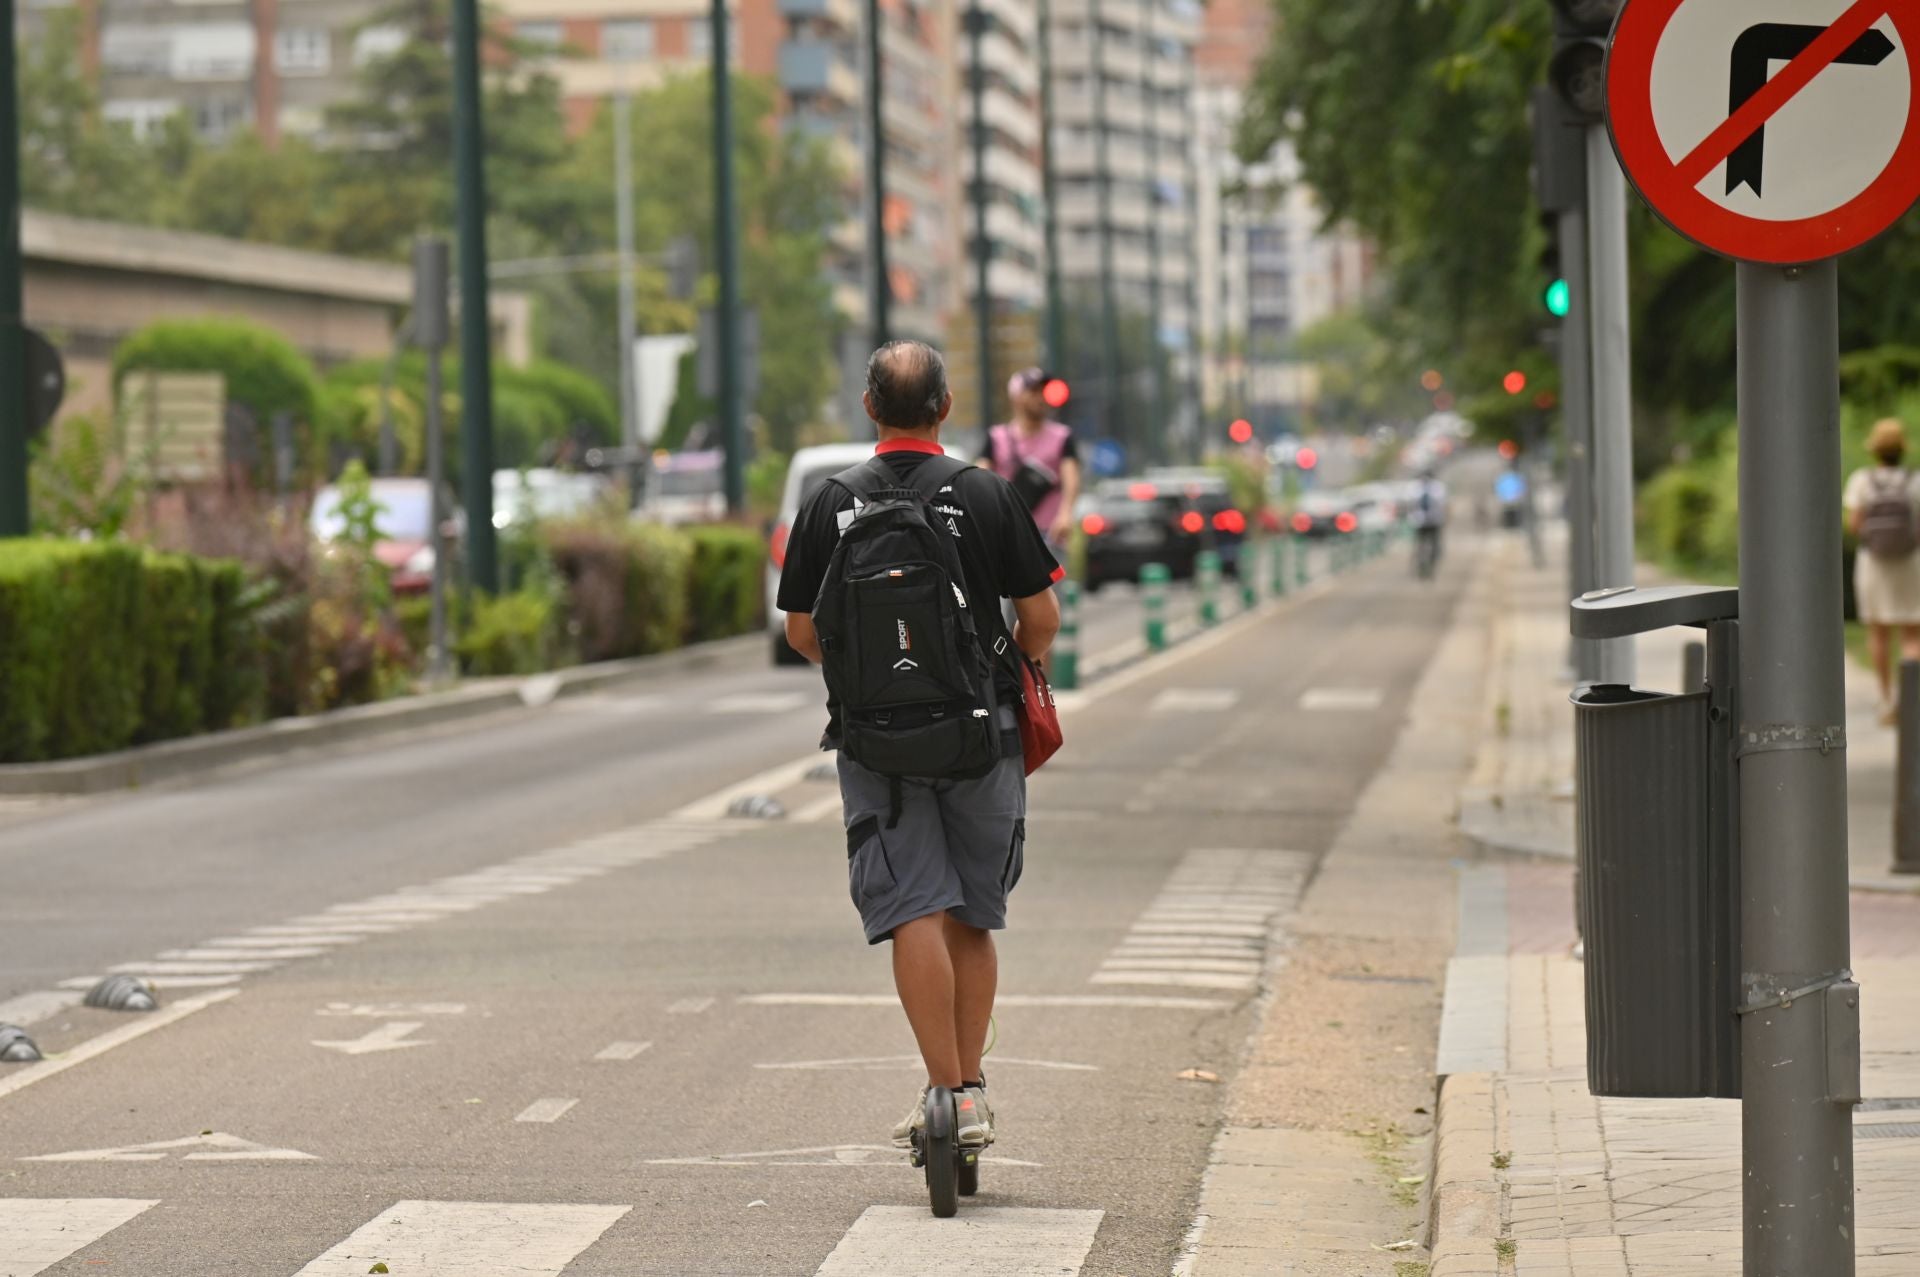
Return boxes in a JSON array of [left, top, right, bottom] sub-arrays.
[[1736, 259, 1860, 1277]]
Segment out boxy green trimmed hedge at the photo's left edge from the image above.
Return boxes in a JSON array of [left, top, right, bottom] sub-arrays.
[[0, 540, 261, 762]]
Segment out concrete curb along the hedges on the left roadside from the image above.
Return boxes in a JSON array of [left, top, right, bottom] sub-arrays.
[[0, 630, 766, 797]]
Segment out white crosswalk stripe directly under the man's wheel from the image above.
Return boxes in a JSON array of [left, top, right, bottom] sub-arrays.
[[814, 1206, 1106, 1277]]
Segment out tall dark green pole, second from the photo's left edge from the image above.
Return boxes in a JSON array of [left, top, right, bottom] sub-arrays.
[[449, 0, 499, 593]]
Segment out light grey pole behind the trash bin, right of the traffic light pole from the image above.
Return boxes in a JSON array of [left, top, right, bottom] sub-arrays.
[[1576, 125, 1634, 684]]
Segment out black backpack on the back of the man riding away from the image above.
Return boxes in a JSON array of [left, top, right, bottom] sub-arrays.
[[814, 455, 1010, 780]]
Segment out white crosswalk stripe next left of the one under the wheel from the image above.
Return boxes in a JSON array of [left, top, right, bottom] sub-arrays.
[[294, 1202, 634, 1277]]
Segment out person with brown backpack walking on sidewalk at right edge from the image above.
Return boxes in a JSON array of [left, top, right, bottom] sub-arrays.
[[1841, 417, 1920, 724]]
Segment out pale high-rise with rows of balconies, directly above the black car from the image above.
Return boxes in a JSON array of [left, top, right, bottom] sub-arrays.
[[1050, 0, 1200, 461]]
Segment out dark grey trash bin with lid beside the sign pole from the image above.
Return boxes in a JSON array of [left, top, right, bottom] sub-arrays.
[[1572, 588, 1740, 1098]]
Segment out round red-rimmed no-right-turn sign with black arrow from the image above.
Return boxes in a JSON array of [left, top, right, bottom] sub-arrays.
[[1607, 0, 1920, 263]]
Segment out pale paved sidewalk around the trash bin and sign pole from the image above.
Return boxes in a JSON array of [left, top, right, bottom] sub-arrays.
[[1430, 533, 1920, 1277]]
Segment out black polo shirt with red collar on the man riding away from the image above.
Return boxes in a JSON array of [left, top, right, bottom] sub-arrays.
[[776, 438, 1066, 739]]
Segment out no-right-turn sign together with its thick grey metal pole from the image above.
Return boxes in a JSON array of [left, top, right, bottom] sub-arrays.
[[1605, 0, 1920, 1277]]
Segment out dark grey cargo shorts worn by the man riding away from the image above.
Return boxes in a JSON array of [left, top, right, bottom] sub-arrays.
[[839, 739, 1027, 945]]
